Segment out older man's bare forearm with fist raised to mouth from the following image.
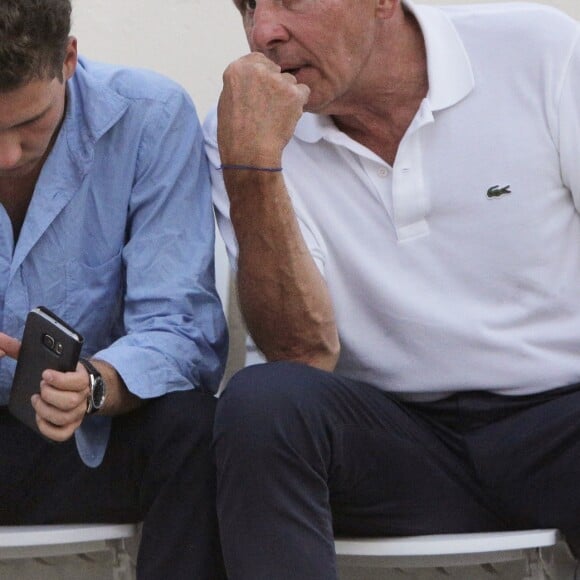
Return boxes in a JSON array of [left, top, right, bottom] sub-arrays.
[[216, 53, 339, 370]]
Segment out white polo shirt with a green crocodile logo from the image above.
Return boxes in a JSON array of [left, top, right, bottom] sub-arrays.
[[205, 2, 580, 399]]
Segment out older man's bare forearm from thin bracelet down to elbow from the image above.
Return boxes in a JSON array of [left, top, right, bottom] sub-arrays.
[[224, 171, 339, 370]]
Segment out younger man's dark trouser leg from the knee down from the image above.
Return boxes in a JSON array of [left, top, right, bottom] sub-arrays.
[[129, 391, 225, 580]]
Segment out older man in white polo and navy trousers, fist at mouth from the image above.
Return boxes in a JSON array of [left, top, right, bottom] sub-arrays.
[[206, 0, 580, 580]]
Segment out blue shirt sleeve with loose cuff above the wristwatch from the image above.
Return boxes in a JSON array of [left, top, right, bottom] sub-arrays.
[[77, 92, 227, 465]]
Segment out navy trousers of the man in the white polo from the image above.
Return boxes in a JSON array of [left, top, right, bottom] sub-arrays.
[[214, 363, 580, 580]]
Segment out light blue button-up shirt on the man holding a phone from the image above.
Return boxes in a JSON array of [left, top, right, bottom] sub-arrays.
[[0, 59, 227, 466]]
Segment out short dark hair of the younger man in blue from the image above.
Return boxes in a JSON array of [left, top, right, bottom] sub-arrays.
[[0, 0, 72, 91]]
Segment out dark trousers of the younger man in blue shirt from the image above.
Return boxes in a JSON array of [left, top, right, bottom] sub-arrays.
[[0, 391, 225, 580]]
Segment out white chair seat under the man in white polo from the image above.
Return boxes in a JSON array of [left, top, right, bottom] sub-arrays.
[[335, 529, 578, 580]]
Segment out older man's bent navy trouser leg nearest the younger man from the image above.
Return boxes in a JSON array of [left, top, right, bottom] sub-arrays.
[[214, 363, 509, 580]]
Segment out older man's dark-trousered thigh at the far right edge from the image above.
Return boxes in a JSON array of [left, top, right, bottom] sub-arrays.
[[468, 387, 580, 547]]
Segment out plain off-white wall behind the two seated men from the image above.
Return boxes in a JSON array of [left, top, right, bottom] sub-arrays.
[[73, 0, 580, 116]]
